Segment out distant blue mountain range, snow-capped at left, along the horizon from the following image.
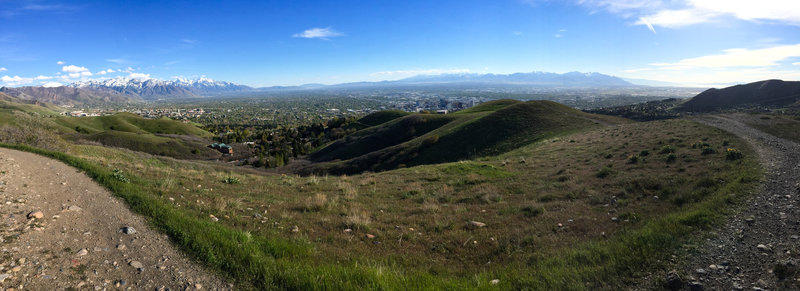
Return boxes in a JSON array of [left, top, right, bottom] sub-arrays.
[[0, 72, 638, 105]]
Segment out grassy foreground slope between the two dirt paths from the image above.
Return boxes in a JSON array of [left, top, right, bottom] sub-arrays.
[[1, 117, 759, 290]]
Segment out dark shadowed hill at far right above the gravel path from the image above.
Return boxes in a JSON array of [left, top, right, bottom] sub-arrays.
[[679, 80, 800, 112]]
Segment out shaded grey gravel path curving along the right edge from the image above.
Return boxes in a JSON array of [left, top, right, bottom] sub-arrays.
[[666, 115, 800, 290]]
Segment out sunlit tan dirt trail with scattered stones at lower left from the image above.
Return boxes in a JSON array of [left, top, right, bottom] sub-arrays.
[[0, 149, 232, 290]]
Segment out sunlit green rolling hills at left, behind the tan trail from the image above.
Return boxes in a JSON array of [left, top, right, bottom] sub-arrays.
[[0, 98, 221, 159]]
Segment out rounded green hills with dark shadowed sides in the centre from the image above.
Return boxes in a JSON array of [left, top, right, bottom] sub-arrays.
[[301, 100, 625, 174]]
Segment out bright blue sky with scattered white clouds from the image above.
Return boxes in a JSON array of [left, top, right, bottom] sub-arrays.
[[0, 0, 800, 87]]
